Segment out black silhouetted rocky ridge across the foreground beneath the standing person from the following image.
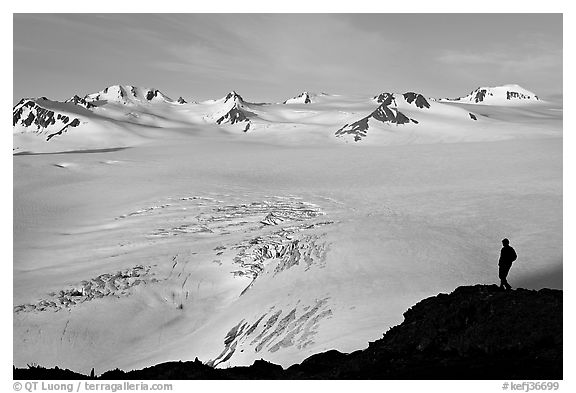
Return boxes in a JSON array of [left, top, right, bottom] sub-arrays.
[[13, 285, 563, 380]]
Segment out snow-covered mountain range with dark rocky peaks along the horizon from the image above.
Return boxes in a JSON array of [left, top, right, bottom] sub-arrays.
[[13, 85, 560, 151]]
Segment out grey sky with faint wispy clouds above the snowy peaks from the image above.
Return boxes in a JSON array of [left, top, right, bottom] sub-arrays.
[[13, 14, 563, 103]]
